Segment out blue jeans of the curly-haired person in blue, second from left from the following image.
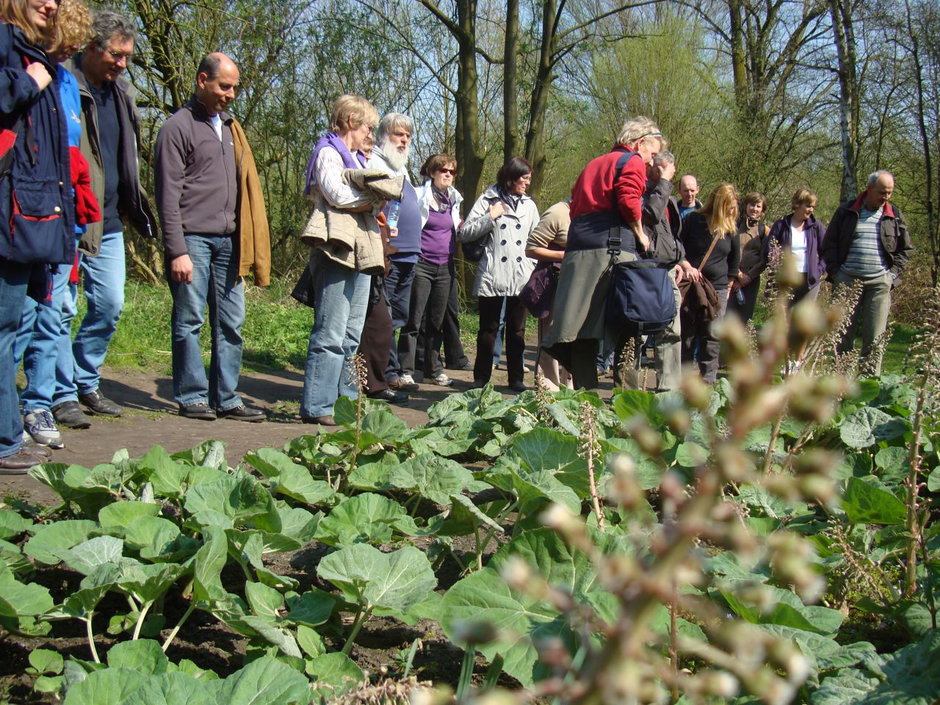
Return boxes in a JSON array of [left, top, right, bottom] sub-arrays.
[[13, 264, 74, 412]]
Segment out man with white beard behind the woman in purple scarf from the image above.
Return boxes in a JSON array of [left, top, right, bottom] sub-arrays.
[[368, 113, 430, 390]]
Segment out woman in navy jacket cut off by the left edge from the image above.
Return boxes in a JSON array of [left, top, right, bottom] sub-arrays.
[[0, 0, 75, 474]]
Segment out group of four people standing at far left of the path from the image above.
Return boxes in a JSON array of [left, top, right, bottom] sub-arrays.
[[0, 0, 270, 474]]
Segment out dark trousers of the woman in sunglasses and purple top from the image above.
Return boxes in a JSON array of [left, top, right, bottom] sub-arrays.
[[398, 259, 453, 376]]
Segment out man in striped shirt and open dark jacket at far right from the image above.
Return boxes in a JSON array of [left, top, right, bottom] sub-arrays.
[[822, 169, 914, 375]]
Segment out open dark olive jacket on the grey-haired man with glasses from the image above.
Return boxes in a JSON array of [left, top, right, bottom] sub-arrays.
[[67, 54, 157, 257]]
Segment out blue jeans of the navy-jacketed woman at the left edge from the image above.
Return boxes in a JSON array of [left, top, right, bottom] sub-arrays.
[[0, 259, 32, 458]]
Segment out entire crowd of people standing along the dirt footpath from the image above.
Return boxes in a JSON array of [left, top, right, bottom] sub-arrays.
[[0, 0, 912, 474]]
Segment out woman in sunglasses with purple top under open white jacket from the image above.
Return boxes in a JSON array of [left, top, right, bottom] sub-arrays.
[[398, 154, 463, 387]]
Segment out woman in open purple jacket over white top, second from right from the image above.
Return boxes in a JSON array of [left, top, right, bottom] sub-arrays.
[[764, 188, 826, 303]]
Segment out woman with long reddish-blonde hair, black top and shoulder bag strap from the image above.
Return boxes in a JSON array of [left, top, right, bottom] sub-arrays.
[[679, 184, 741, 384]]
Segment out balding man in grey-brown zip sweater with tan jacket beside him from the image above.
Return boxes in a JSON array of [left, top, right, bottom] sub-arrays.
[[154, 53, 271, 422]]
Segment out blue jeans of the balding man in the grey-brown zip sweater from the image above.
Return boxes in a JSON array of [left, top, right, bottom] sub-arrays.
[[170, 235, 245, 411]]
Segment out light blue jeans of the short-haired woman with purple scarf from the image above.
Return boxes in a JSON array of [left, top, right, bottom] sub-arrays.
[[300, 251, 370, 417]]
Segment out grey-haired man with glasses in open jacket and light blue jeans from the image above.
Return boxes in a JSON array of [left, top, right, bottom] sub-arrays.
[[52, 10, 156, 428]]
